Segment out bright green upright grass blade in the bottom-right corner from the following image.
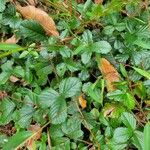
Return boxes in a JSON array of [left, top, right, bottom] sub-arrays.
[[144, 122, 150, 150]]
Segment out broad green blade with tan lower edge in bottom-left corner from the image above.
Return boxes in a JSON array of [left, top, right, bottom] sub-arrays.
[[3, 131, 33, 150]]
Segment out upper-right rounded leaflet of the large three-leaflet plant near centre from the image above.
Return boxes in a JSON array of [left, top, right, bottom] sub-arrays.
[[59, 77, 82, 98]]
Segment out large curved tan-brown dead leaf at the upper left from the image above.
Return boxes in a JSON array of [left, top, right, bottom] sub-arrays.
[[16, 5, 59, 36]]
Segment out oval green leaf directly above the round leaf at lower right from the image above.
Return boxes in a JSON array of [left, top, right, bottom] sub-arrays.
[[121, 112, 136, 130]]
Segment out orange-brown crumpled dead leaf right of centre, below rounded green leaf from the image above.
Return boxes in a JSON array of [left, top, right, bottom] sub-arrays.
[[99, 58, 119, 91]]
